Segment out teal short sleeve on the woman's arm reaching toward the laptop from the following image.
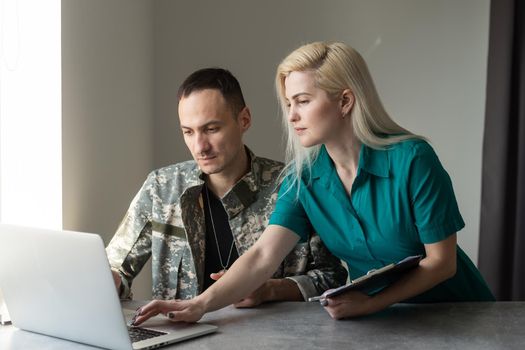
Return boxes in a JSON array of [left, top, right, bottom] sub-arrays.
[[269, 176, 312, 243]]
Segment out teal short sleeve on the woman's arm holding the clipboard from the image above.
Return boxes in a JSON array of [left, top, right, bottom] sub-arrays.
[[408, 142, 465, 244]]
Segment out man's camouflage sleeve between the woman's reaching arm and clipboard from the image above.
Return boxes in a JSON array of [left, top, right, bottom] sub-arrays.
[[284, 233, 348, 300]]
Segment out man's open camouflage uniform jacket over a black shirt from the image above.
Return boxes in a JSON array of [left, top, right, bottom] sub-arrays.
[[106, 150, 347, 299]]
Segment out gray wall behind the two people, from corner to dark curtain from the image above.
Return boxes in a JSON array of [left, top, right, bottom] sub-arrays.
[[154, 0, 489, 261]]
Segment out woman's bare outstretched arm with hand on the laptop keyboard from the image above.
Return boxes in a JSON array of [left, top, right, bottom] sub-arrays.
[[133, 225, 299, 325]]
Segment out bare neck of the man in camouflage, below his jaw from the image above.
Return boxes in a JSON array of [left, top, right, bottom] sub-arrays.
[[206, 147, 250, 198]]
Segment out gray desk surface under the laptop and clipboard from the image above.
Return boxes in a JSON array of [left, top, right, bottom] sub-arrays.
[[0, 302, 525, 350]]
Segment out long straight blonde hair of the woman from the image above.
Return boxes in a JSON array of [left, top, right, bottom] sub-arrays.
[[275, 42, 424, 194]]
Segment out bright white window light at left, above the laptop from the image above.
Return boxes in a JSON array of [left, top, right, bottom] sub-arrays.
[[0, 0, 62, 228]]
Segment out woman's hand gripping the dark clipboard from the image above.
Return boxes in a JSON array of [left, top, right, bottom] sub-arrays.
[[324, 291, 374, 320]]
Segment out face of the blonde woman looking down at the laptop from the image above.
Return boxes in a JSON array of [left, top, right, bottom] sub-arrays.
[[284, 71, 343, 147]]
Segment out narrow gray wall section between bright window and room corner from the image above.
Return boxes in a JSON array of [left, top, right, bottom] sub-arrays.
[[62, 0, 154, 297]]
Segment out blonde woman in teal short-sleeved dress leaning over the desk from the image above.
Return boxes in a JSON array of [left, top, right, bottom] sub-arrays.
[[136, 42, 494, 324]]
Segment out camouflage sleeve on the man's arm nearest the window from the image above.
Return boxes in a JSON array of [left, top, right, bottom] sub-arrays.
[[106, 173, 155, 299]]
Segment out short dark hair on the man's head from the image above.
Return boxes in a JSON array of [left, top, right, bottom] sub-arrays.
[[177, 68, 246, 117]]
